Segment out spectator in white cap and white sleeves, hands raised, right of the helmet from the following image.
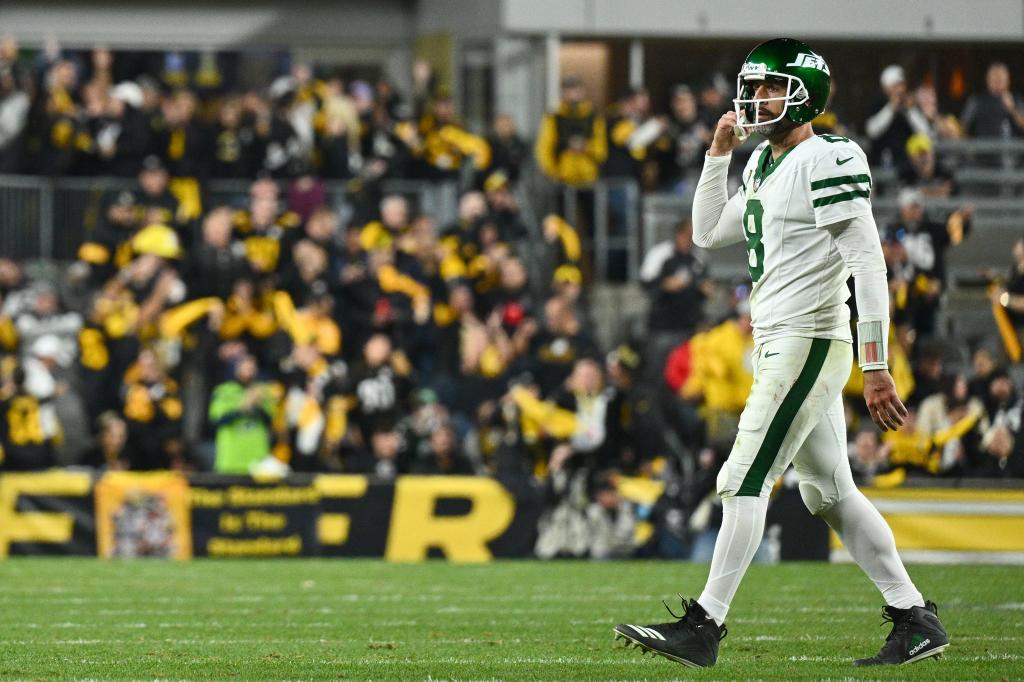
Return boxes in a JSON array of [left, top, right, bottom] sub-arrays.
[[864, 65, 928, 168]]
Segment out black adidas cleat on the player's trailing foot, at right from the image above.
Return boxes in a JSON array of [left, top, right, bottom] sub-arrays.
[[853, 601, 949, 666]]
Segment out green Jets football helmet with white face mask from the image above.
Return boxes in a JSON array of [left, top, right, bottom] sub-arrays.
[[732, 38, 831, 133]]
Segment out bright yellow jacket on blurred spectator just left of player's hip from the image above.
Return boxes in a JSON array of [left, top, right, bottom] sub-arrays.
[[680, 319, 754, 415]]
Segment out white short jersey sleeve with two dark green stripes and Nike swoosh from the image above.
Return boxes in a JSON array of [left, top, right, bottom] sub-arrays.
[[810, 143, 871, 227]]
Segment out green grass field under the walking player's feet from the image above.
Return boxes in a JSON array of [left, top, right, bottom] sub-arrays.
[[0, 559, 1024, 680]]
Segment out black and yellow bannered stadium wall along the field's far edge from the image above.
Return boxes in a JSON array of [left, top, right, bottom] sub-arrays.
[[0, 470, 1024, 563]]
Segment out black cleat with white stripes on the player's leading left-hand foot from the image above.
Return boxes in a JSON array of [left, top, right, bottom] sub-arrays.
[[615, 599, 726, 668]]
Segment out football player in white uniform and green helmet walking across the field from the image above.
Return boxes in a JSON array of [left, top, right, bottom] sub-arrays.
[[615, 38, 949, 667]]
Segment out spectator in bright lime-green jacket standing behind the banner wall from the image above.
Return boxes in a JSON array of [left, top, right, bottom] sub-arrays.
[[210, 355, 274, 474]]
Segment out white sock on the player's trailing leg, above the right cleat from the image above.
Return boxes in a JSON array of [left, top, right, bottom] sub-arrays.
[[821, 491, 925, 608]]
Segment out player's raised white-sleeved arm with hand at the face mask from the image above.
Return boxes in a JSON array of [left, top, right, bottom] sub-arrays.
[[693, 112, 743, 249]]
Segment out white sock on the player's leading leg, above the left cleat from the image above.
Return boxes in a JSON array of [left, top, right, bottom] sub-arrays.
[[697, 497, 768, 625]]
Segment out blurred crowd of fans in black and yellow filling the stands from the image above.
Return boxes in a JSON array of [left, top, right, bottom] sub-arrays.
[[0, 40, 1024, 557]]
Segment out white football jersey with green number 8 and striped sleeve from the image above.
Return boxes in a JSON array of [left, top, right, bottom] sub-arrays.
[[730, 135, 871, 343]]
